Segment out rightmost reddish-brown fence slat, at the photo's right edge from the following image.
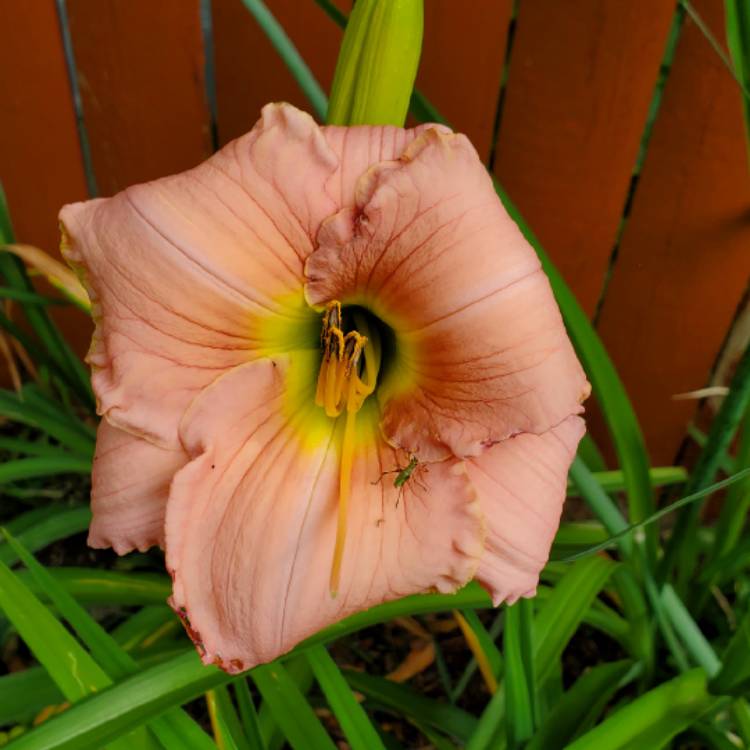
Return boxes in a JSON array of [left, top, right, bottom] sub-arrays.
[[599, 0, 750, 462]]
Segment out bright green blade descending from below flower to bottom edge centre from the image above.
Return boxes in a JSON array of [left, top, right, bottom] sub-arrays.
[[305, 646, 383, 750]]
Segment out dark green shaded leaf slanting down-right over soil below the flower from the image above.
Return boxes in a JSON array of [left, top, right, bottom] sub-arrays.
[[342, 669, 476, 743]]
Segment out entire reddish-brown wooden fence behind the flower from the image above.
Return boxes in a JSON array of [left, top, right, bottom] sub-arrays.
[[0, 0, 750, 463]]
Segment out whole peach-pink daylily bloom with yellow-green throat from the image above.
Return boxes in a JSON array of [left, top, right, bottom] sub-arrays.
[[61, 104, 589, 672]]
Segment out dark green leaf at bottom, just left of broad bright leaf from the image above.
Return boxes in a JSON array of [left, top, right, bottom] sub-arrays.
[[525, 660, 635, 750]]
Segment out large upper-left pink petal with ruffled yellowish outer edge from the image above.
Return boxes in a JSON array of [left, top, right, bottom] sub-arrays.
[[60, 104, 338, 447]]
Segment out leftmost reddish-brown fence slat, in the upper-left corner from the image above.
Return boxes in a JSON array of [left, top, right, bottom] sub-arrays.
[[0, 0, 86, 253]]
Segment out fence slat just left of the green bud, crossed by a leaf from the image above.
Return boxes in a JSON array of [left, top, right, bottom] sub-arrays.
[[212, 0, 351, 144]]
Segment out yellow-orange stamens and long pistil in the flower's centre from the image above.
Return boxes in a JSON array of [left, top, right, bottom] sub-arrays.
[[315, 300, 380, 597]]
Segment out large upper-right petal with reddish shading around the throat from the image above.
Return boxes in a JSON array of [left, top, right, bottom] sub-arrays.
[[305, 129, 589, 460]]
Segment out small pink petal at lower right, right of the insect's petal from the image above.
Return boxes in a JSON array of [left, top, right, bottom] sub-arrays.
[[466, 417, 586, 606]]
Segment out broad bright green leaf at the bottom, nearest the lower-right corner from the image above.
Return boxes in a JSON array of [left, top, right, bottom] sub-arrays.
[[567, 669, 726, 750]]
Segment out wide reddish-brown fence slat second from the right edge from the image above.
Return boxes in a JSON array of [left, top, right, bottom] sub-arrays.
[[495, 0, 675, 313]]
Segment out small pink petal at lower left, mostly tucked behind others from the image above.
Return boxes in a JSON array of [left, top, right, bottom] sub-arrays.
[[88, 419, 187, 555]]
